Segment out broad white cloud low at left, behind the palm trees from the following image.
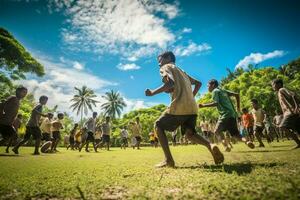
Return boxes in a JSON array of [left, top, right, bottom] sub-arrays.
[[20, 55, 117, 119]]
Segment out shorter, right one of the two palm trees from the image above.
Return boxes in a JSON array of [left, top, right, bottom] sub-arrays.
[[101, 90, 126, 119]]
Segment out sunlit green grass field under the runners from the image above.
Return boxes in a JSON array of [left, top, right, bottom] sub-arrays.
[[0, 141, 300, 199]]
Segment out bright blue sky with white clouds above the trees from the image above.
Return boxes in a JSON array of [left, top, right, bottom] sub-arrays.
[[0, 0, 300, 117]]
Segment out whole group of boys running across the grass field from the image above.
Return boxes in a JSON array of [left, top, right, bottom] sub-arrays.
[[0, 51, 300, 167]]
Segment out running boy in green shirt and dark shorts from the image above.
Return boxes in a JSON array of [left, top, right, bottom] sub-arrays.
[[199, 79, 254, 152]]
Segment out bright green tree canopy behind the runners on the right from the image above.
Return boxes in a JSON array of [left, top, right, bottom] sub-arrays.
[[199, 58, 300, 119]]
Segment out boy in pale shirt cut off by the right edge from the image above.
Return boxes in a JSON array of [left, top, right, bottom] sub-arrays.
[[272, 79, 300, 148]]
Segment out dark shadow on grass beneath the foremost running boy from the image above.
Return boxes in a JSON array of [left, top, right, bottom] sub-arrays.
[[176, 162, 285, 176]]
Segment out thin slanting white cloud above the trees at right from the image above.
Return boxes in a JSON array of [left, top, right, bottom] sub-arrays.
[[235, 50, 286, 69]]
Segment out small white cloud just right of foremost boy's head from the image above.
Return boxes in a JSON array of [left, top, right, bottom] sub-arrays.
[[174, 42, 212, 56]]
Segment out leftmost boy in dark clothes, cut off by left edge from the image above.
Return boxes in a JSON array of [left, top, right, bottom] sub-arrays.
[[0, 86, 27, 152]]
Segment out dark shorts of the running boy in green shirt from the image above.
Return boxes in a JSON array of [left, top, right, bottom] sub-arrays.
[[215, 117, 242, 138]]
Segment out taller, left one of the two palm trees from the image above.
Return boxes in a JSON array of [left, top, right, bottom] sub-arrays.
[[70, 86, 98, 122]]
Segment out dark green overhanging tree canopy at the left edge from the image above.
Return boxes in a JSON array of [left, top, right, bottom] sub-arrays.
[[0, 27, 45, 98]]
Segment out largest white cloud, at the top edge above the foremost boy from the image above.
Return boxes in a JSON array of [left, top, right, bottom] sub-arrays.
[[50, 0, 179, 58]]
